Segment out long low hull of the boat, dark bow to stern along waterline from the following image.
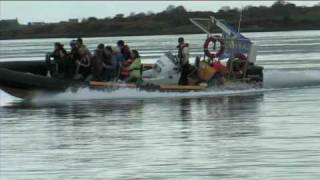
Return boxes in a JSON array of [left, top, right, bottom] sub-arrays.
[[0, 61, 262, 99]]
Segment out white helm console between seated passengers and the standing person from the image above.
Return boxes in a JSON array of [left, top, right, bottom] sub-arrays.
[[142, 52, 180, 85]]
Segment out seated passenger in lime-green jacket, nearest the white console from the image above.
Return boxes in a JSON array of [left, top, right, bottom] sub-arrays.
[[126, 50, 141, 82]]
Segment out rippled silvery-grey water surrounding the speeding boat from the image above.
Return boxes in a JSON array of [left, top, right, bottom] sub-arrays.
[[0, 31, 320, 180]]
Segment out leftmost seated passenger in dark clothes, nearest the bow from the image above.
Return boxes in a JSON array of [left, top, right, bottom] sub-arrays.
[[46, 42, 67, 76]]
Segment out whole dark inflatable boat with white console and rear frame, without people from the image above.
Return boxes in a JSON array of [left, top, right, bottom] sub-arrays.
[[0, 17, 263, 98]]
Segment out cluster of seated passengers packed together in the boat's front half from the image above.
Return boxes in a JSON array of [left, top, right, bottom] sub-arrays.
[[46, 38, 141, 82]]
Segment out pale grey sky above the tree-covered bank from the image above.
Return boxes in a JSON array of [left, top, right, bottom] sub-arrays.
[[0, 1, 319, 24]]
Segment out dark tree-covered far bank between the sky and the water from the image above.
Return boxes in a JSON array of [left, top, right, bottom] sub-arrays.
[[0, 1, 320, 39]]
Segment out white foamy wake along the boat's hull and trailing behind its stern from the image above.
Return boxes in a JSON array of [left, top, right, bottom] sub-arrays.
[[0, 70, 320, 106]]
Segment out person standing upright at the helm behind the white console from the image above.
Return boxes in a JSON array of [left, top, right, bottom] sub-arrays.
[[177, 37, 189, 85]]
